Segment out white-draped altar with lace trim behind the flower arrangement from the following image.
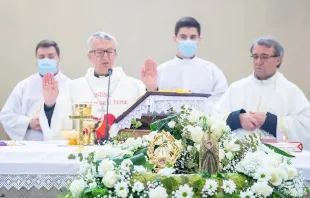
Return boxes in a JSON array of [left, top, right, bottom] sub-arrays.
[[0, 141, 310, 198]]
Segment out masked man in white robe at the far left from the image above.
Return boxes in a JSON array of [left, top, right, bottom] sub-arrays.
[[0, 40, 69, 141]]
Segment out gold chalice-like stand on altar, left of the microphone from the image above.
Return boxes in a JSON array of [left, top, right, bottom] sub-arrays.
[[69, 104, 94, 152]]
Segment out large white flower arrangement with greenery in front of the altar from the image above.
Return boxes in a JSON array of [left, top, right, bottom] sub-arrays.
[[66, 107, 307, 198]]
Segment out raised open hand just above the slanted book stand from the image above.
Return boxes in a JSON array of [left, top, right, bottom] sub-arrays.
[[141, 59, 157, 91]]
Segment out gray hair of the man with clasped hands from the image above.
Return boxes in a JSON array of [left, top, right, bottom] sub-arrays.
[[250, 37, 284, 68]]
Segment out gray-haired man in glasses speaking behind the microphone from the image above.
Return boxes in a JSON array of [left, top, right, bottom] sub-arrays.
[[40, 32, 146, 140]]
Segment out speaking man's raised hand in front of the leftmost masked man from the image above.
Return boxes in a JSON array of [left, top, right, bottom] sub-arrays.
[[42, 73, 59, 107]]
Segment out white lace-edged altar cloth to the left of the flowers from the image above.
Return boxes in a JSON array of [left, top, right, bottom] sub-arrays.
[[0, 141, 96, 190]]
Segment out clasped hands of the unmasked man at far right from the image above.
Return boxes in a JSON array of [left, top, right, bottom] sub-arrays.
[[239, 112, 267, 131]]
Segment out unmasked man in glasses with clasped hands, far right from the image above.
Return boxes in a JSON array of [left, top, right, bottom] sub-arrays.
[[214, 37, 310, 150]]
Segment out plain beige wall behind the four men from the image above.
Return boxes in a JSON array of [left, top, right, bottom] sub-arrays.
[[0, 0, 310, 139]]
